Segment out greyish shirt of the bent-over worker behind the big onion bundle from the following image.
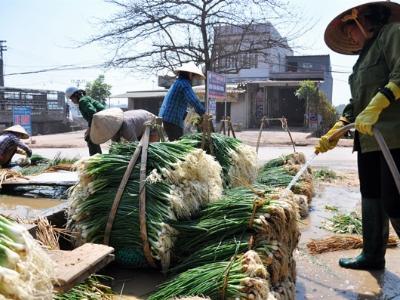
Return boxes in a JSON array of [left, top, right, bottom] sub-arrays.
[[114, 109, 156, 141]]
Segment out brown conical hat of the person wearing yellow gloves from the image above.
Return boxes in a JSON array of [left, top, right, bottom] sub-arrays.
[[324, 1, 400, 55]]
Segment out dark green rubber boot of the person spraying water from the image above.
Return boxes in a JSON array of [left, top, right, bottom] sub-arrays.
[[339, 198, 389, 270]]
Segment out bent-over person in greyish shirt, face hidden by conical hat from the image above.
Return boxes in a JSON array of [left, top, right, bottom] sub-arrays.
[[90, 108, 159, 144]]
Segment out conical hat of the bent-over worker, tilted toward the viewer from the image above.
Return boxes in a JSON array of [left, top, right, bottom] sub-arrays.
[[90, 108, 124, 144]]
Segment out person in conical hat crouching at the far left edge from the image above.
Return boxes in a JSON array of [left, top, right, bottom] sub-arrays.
[[0, 125, 32, 168]]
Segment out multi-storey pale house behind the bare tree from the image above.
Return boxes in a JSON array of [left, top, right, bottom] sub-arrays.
[[213, 23, 332, 128]]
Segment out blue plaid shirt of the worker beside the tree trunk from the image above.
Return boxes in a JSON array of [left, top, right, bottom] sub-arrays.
[[159, 78, 206, 128]]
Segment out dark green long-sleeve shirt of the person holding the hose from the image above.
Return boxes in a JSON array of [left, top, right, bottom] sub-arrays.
[[343, 23, 400, 152]]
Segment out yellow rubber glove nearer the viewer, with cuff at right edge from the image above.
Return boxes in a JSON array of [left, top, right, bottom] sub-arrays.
[[355, 82, 400, 135]]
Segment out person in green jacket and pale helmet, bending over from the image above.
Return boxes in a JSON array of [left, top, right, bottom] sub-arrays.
[[65, 87, 105, 155]]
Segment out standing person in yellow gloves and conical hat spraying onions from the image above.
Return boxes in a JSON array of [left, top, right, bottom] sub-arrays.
[[315, 1, 400, 270]]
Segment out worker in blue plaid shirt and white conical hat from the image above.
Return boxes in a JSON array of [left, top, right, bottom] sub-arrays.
[[159, 63, 206, 141]]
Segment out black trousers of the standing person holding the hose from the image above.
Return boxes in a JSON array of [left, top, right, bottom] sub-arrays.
[[357, 149, 400, 218]]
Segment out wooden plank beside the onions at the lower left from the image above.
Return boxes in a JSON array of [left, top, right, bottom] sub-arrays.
[[49, 243, 114, 292]]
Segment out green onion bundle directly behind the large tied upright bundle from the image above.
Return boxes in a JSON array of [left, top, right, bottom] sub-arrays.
[[181, 133, 257, 187]]
